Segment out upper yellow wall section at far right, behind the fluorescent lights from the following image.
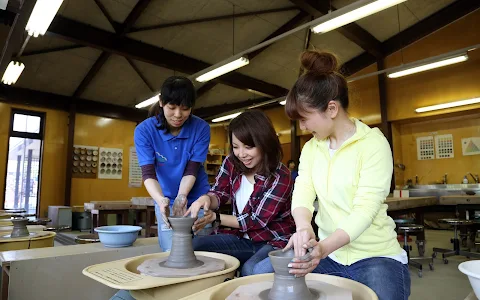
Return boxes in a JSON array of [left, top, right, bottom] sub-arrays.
[[385, 10, 480, 121]]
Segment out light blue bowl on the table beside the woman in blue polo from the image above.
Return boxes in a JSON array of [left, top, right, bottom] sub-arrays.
[[95, 225, 142, 248]]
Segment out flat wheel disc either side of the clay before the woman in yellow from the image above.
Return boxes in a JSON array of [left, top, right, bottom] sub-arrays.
[[226, 280, 353, 300]]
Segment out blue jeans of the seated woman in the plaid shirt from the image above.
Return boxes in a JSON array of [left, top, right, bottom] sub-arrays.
[[193, 234, 274, 276]]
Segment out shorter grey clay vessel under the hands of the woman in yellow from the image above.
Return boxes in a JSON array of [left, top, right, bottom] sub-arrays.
[[268, 250, 317, 300]]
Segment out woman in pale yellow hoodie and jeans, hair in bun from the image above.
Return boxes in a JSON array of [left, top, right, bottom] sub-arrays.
[[285, 51, 410, 300]]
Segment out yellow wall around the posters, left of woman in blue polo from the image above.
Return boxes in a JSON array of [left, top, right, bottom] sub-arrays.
[[71, 114, 148, 205]]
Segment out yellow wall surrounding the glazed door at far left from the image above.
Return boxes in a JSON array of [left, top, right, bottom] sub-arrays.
[[0, 103, 68, 216]]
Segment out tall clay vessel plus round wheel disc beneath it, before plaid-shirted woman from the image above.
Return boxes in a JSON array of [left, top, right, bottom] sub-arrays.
[[137, 217, 225, 277]]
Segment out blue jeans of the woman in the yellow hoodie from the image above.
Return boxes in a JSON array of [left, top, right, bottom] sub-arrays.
[[312, 257, 410, 300]]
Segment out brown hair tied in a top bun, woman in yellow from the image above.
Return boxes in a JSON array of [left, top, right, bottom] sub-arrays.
[[285, 50, 348, 120]]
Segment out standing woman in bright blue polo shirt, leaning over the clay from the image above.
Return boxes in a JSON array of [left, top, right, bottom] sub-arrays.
[[134, 76, 210, 251]]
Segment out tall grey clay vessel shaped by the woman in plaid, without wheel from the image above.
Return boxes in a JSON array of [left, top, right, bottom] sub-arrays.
[[160, 217, 203, 269]]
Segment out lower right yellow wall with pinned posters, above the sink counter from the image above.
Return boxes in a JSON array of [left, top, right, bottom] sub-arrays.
[[395, 114, 480, 184]]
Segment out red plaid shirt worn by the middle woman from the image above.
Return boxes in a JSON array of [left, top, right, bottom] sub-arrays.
[[210, 156, 295, 248]]
